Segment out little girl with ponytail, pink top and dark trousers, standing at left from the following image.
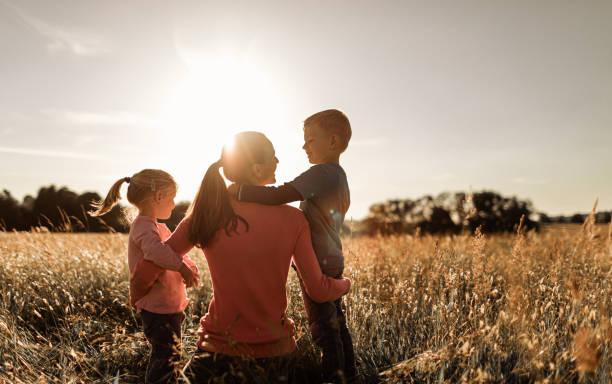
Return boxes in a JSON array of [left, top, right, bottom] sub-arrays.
[[91, 169, 199, 383]]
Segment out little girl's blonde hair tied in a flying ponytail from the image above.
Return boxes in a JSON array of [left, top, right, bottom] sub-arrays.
[[89, 169, 177, 216]]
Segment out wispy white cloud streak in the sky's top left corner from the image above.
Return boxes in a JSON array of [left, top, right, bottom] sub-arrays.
[[1, 0, 112, 56]]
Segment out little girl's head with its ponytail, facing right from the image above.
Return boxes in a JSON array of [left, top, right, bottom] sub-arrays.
[[90, 169, 177, 219]]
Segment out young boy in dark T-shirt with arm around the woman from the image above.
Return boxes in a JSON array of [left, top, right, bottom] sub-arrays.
[[230, 109, 356, 382]]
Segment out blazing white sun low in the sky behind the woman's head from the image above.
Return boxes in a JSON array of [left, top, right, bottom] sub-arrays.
[[155, 55, 285, 198]]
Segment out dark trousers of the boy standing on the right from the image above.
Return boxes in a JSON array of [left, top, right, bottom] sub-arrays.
[[300, 272, 357, 383]]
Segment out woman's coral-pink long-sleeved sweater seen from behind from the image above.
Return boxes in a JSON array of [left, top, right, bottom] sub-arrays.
[[166, 201, 350, 358]]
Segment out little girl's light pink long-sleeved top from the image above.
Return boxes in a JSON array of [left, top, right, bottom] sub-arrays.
[[128, 215, 195, 313]]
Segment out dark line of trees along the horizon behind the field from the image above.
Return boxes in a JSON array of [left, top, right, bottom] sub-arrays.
[[0, 185, 611, 235]]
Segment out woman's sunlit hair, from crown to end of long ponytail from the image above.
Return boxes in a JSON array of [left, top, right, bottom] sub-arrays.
[[186, 132, 274, 248]]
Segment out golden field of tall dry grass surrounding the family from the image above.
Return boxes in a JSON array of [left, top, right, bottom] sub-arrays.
[[0, 222, 612, 383]]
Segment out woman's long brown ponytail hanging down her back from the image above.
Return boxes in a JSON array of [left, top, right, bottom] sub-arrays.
[[186, 160, 249, 248]]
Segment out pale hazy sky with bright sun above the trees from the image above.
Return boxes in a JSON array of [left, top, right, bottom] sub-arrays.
[[0, 0, 612, 220]]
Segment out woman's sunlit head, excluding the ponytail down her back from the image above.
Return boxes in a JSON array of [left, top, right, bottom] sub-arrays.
[[221, 131, 278, 185]]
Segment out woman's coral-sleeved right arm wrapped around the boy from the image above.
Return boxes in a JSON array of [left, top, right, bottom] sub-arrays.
[[293, 220, 351, 303]]
